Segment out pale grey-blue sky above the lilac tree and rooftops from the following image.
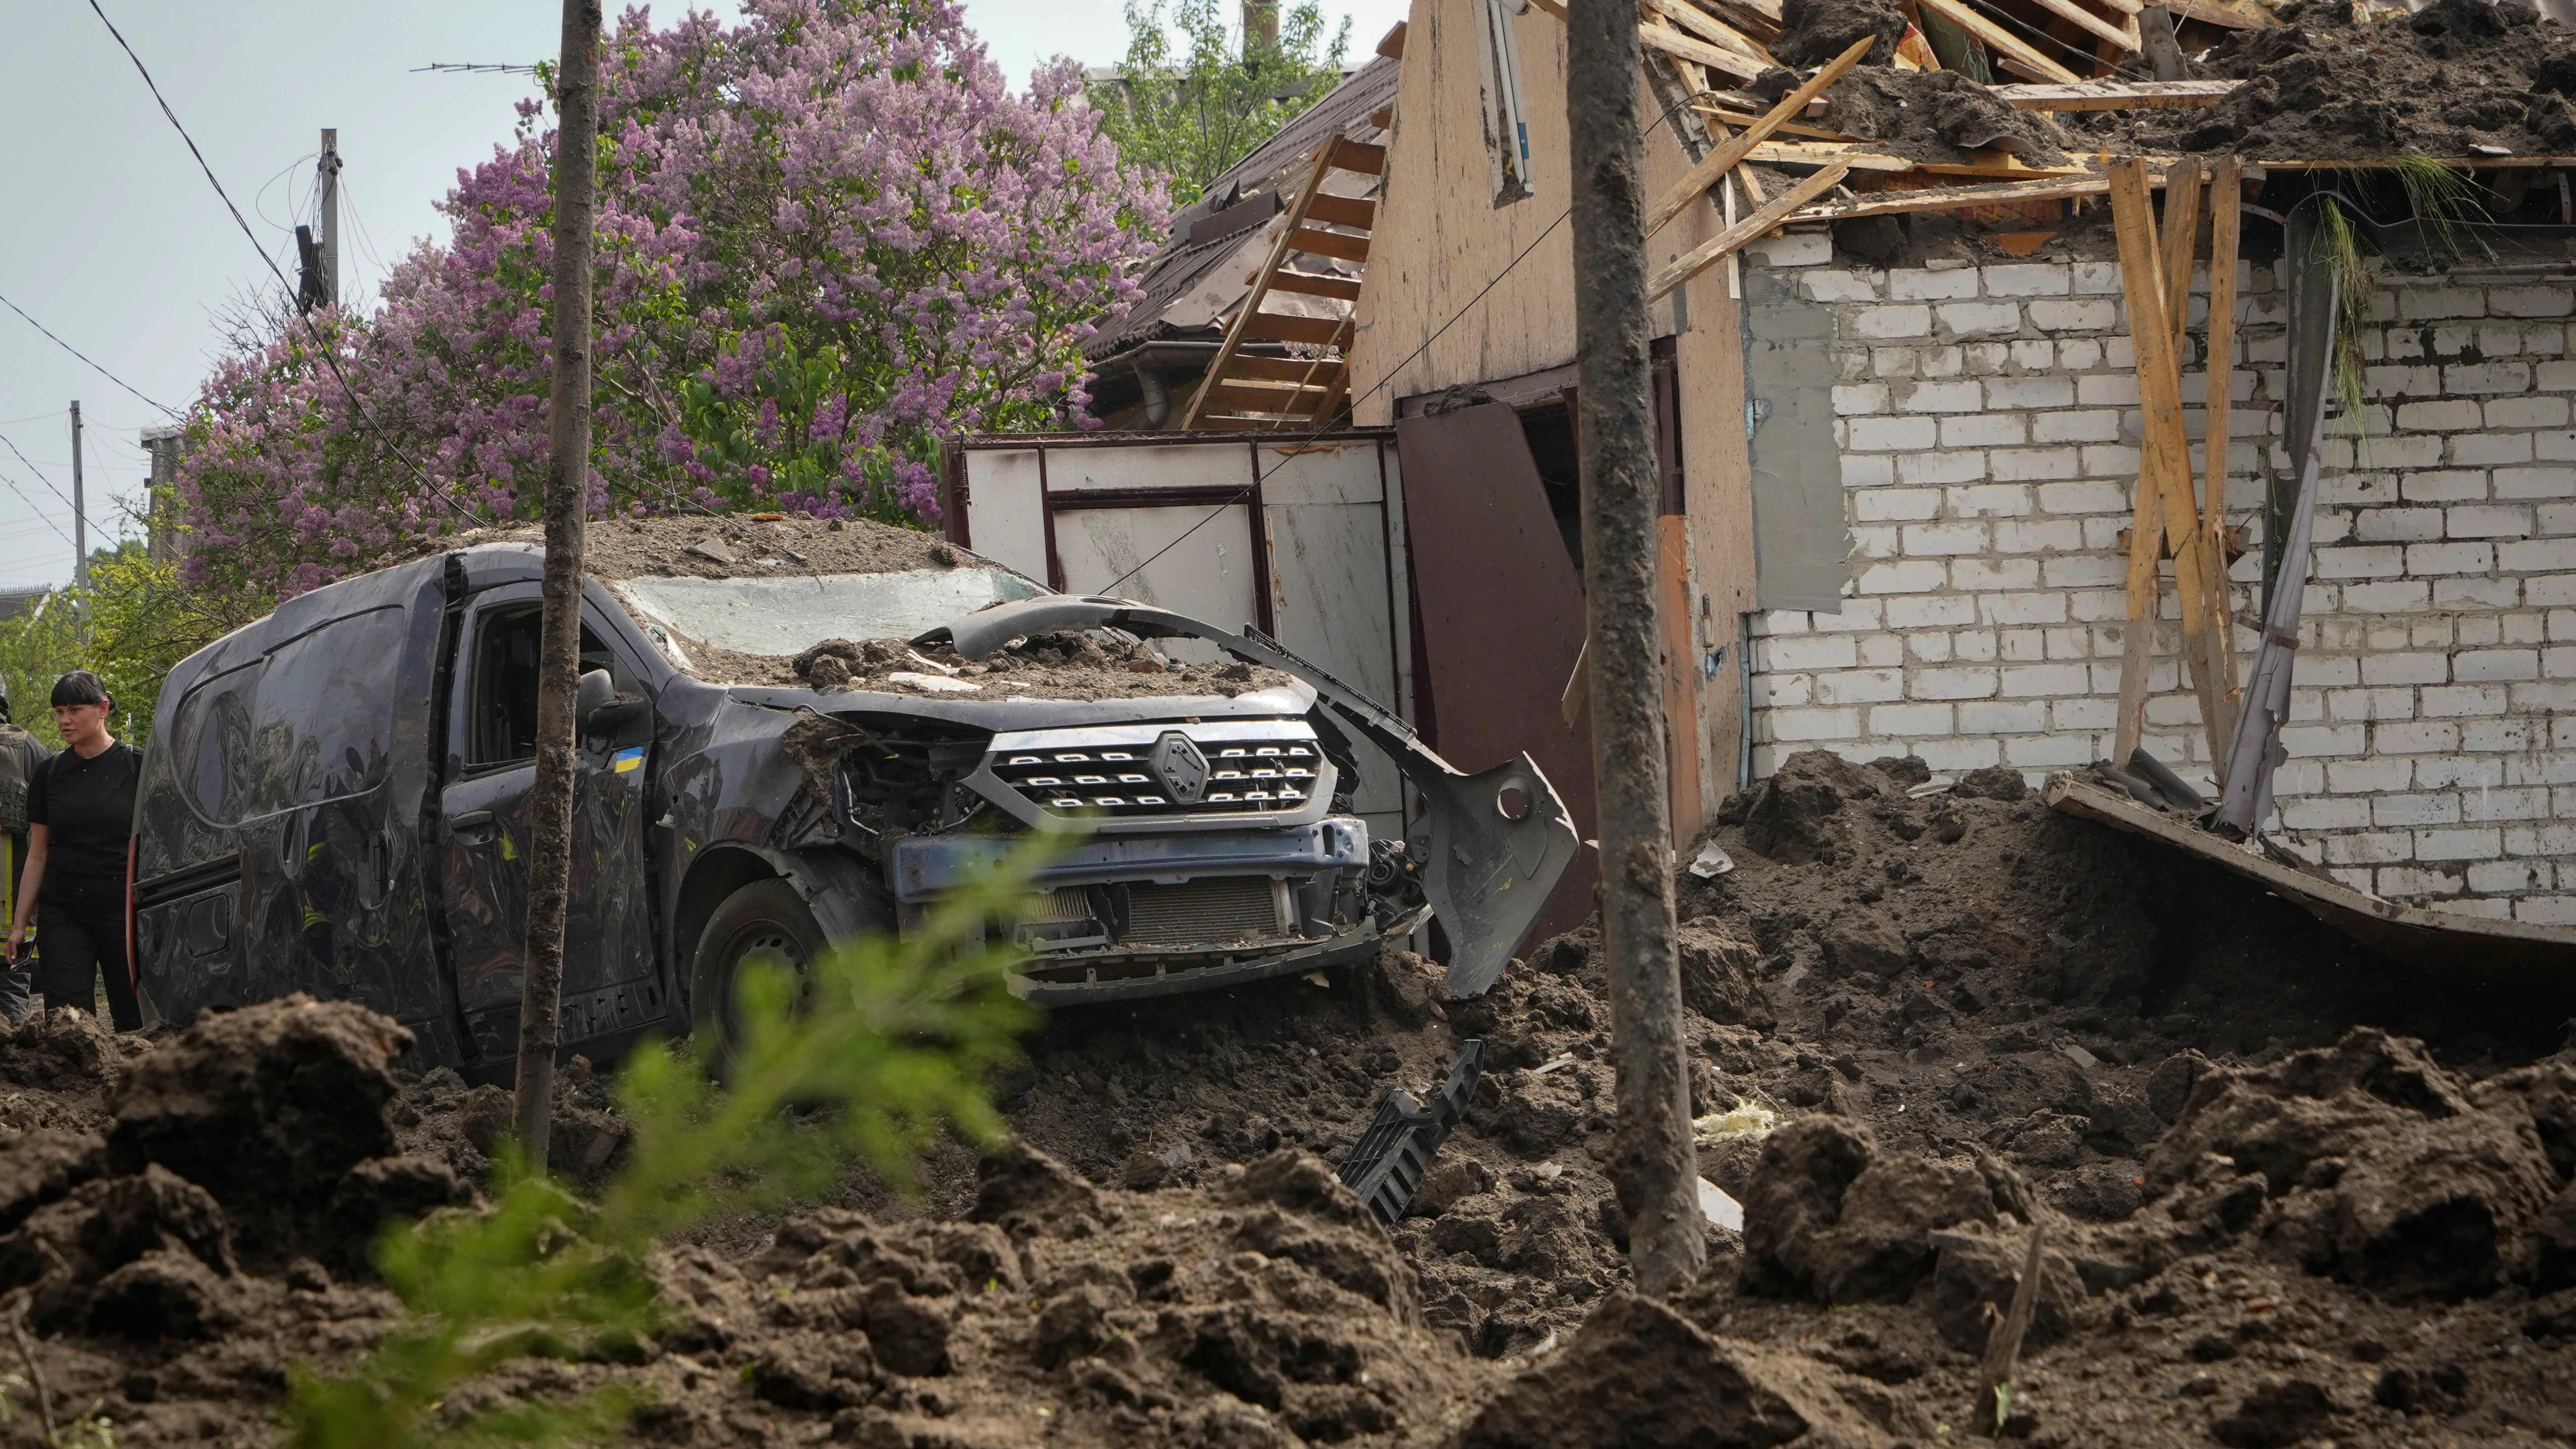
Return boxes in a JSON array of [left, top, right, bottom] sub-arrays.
[[0, 0, 1407, 590]]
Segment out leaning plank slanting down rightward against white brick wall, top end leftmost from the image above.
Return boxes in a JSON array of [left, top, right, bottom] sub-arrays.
[[2110, 160, 2218, 761]]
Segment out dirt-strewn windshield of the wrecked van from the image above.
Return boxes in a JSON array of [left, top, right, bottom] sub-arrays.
[[615, 566, 1046, 654]]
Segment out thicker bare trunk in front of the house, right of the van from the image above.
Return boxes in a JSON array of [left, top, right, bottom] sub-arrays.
[[1566, 3, 1708, 1297]]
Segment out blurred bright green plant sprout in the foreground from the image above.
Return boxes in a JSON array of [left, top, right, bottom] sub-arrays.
[[286, 834, 1069, 1449]]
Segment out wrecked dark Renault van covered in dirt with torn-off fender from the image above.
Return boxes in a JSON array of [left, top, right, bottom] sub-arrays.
[[134, 522, 1579, 1078]]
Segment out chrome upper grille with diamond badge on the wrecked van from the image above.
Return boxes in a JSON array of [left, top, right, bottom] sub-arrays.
[[984, 720, 1332, 821]]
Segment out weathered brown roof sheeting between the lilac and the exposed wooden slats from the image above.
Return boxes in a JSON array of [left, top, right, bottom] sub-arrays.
[[1082, 57, 1399, 363]]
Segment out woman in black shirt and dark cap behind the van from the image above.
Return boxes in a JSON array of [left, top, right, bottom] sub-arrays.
[[8, 669, 144, 1032]]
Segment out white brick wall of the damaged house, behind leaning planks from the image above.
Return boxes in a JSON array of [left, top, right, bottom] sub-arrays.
[[1752, 245, 2576, 922]]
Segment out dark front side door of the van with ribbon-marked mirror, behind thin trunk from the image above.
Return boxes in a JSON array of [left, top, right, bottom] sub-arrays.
[[438, 584, 662, 1063]]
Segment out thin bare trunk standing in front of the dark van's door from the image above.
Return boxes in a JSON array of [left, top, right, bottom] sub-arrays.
[[515, 0, 600, 1171]]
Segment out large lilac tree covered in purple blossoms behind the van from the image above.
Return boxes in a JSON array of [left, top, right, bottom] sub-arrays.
[[180, 0, 1167, 597]]
